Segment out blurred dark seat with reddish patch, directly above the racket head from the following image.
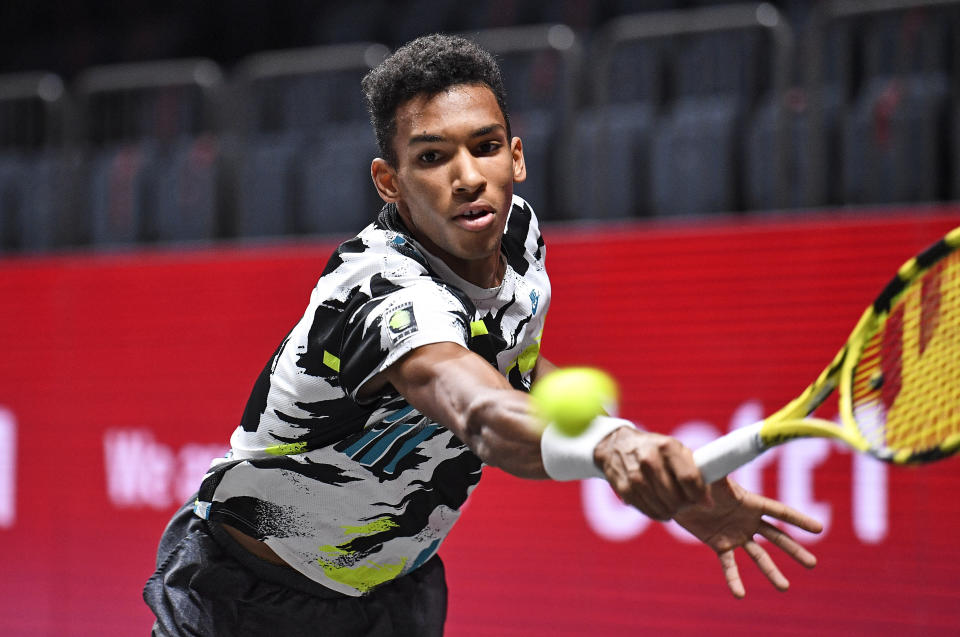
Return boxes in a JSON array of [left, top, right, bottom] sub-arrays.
[[841, 9, 957, 204]]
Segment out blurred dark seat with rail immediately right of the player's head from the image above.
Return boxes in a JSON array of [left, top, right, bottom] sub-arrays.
[[471, 24, 582, 220]]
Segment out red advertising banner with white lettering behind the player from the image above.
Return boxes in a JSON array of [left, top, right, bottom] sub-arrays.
[[0, 207, 960, 637]]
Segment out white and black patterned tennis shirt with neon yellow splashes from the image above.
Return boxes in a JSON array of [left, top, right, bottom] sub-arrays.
[[195, 196, 550, 596]]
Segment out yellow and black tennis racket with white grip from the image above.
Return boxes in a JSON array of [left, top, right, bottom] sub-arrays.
[[693, 228, 960, 483]]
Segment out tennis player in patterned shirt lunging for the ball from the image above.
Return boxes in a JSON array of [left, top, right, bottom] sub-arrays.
[[144, 35, 820, 637]]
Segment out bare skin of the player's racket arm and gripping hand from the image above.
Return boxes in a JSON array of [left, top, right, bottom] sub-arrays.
[[372, 343, 706, 520]]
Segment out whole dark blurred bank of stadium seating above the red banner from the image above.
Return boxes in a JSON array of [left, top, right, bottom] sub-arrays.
[[0, 0, 960, 252]]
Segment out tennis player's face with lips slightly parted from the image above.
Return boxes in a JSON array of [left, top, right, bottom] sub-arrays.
[[376, 85, 526, 286]]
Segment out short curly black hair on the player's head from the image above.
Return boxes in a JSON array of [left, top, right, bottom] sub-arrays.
[[361, 34, 510, 166]]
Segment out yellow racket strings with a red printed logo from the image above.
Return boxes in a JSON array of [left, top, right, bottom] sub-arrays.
[[852, 251, 960, 456]]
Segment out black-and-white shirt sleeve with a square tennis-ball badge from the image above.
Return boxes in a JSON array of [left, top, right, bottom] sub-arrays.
[[340, 279, 472, 399]]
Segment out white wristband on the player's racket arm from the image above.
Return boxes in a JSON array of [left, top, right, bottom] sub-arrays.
[[540, 416, 636, 481]]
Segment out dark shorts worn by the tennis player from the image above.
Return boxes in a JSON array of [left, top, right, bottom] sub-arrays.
[[143, 500, 447, 637]]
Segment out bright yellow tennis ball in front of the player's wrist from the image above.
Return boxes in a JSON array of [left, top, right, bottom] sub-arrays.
[[530, 367, 619, 436]]
